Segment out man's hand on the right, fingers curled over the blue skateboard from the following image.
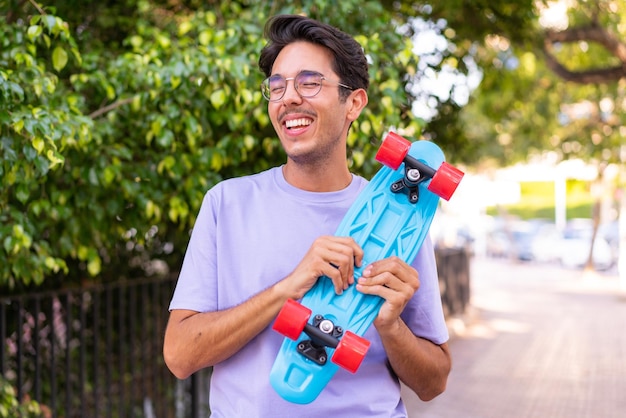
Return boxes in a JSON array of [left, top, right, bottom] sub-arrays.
[[357, 257, 420, 334]]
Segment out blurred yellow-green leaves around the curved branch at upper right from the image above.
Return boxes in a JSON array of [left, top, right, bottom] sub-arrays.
[[460, 2, 626, 169]]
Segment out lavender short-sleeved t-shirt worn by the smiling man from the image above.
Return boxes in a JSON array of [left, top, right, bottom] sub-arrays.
[[170, 167, 448, 418]]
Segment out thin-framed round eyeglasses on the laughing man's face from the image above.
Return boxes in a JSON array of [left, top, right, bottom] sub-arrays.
[[261, 71, 354, 102]]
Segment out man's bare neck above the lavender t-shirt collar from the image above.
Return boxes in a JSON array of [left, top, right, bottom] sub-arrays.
[[283, 160, 352, 192]]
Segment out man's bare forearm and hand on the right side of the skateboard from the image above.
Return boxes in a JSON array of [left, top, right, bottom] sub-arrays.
[[358, 257, 452, 400]]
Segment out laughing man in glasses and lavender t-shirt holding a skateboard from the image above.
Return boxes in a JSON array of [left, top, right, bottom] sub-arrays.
[[164, 16, 451, 418]]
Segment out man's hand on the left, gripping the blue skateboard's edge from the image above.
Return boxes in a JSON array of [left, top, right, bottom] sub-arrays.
[[281, 236, 363, 299]]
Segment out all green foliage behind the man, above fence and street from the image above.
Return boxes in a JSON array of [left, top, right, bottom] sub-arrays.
[[0, 0, 626, 288]]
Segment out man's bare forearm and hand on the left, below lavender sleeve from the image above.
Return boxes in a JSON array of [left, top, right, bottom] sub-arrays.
[[163, 236, 363, 379]]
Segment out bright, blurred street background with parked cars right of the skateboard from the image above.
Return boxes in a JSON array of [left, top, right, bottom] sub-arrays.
[[432, 160, 623, 272]]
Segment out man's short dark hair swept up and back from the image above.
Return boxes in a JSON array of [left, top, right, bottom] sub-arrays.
[[259, 15, 369, 98]]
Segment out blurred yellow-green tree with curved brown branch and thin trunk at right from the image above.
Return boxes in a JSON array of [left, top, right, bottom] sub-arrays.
[[460, 1, 626, 268]]
